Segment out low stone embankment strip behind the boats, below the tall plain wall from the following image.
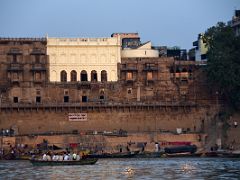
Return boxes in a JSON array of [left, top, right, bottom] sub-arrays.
[[1, 133, 205, 152]]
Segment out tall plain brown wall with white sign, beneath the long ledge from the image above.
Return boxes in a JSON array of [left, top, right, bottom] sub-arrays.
[[0, 107, 212, 134]]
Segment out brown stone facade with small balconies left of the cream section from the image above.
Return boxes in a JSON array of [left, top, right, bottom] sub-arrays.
[[0, 38, 49, 104]]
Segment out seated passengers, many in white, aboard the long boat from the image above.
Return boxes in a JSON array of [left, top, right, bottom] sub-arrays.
[[42, 152, 84, 161]]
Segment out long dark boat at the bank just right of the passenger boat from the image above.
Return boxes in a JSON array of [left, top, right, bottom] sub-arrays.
[[87, 151, 139, 158]]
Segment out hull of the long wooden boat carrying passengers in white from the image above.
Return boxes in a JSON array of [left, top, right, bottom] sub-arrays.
[[30, 158, 98, 166]]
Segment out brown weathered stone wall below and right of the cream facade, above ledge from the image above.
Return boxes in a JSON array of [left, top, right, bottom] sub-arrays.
[[1, 58, 210, 104]]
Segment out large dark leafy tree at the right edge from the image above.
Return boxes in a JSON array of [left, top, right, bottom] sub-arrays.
[[204, 23, 240, 108]]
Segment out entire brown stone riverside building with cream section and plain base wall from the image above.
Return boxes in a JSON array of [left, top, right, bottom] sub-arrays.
[[0, 34, 216, 134]]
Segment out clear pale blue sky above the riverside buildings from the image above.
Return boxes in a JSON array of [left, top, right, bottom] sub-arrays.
[[0, 0, 240, 49]]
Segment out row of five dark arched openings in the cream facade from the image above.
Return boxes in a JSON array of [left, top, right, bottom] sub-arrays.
[[60, 70, 107, 82]]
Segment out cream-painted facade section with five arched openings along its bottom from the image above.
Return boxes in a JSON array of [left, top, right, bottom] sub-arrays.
[[47, 37, 121, 82]]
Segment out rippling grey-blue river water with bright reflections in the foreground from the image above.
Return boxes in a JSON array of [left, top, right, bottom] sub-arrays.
[[0, 158, 240, 180]]
